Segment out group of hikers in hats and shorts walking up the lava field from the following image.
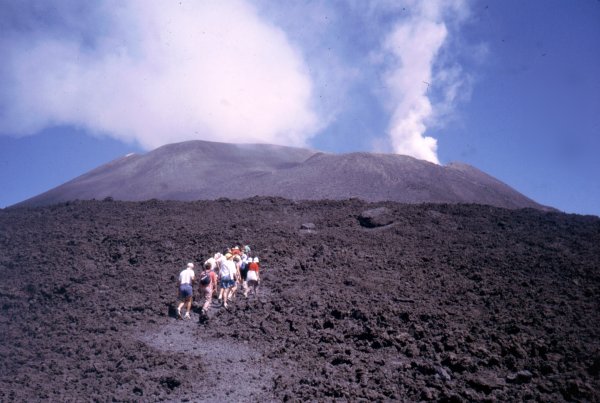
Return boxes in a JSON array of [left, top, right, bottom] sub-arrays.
[[177, 245, 260, 319]]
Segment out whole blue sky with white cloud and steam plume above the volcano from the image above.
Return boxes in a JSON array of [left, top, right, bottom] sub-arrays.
[[0, 0, 600, 215]]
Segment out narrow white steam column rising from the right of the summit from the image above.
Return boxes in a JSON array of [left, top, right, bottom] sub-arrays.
[[383, 0, 468, 164]]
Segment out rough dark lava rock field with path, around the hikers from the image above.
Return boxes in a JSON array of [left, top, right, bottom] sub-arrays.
[[0, 198, 600, 401]]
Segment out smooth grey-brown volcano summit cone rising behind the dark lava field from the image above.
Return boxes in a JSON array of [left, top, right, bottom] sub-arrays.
[[20, 140, 548, 210]]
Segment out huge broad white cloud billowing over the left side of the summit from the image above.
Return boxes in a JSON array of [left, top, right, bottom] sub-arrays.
[[0, 0, 320, 148]]
